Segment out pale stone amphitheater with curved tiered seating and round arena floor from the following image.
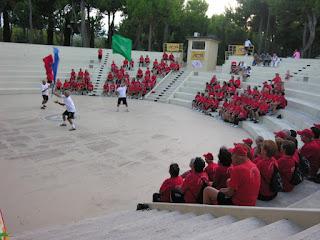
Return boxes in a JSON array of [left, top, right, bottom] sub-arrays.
[[0, 43, 320, 240]]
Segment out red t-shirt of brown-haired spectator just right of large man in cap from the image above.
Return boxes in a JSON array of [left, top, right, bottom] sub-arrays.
[[257, 157, 278, 197]]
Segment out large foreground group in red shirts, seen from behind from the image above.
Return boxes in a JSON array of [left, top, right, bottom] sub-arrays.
[[153, 124, 320, 206]]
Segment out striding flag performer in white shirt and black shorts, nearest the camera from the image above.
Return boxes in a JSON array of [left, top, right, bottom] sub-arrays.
[[54, 91, 76, 131]]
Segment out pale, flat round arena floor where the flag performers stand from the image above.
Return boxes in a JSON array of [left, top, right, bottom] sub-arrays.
[[0, 95, 248, 234]]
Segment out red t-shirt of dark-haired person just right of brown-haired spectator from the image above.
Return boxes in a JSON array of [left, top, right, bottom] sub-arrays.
[[278, 155, 296, 192]]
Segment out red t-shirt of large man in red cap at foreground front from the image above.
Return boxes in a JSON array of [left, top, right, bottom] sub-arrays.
[[228, 159, 260, 206]]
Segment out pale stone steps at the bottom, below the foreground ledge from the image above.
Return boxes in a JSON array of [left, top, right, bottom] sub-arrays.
[[12, 204, 320, 240]]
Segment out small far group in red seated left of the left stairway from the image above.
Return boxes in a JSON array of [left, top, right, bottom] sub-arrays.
[[56, 68, 93, 95]]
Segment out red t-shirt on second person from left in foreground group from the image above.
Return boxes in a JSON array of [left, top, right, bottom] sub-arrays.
[[182, 171, 208, 203]]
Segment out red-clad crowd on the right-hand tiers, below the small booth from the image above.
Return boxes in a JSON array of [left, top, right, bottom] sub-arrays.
[[192, 73, 287, 125]]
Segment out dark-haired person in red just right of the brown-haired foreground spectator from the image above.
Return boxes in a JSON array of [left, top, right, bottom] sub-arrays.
[[277, 140, 298, 192]]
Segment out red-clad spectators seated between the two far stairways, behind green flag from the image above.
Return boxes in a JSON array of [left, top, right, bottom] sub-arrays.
[[103, 53, 180, 98]]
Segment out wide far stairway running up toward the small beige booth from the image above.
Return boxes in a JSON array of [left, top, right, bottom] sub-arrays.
[[145, 69, 190, 103]]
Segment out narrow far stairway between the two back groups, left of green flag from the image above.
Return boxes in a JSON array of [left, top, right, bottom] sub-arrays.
[[88, 51, 109, 96]]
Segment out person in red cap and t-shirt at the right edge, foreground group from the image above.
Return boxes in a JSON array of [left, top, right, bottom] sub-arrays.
[[297, 129, 320, 180]]
